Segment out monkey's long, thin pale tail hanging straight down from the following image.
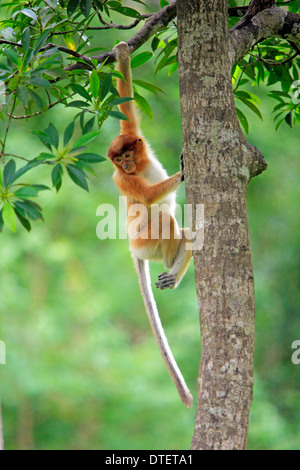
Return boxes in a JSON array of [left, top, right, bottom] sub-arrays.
[[133, 256, 193, 408]]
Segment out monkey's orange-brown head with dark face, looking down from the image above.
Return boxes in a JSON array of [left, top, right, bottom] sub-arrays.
[[107, 135, 144, 173]]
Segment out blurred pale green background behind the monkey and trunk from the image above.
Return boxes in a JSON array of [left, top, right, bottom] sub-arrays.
[[0, 18, 300, 450]]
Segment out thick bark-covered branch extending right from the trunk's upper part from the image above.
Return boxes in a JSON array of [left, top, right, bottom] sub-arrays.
[[230, 6, 300, 65]]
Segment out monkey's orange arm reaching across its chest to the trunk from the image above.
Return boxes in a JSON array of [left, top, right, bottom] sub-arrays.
[[114, 172, 182, 206]]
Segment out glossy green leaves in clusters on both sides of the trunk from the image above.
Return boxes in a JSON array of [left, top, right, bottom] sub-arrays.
[[0, 0, 300, 231]]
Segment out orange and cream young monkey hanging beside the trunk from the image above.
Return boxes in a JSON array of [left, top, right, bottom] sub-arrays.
[[108, 42, 193, 408]]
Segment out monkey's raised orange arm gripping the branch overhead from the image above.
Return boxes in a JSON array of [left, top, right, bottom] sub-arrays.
[[114, 42, 140, 135]]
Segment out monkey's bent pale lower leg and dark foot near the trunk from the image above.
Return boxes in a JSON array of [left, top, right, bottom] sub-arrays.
[[156, 229, 192, 290]]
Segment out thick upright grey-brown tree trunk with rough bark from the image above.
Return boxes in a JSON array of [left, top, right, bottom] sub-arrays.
[[177, 0, 264, 450]]
